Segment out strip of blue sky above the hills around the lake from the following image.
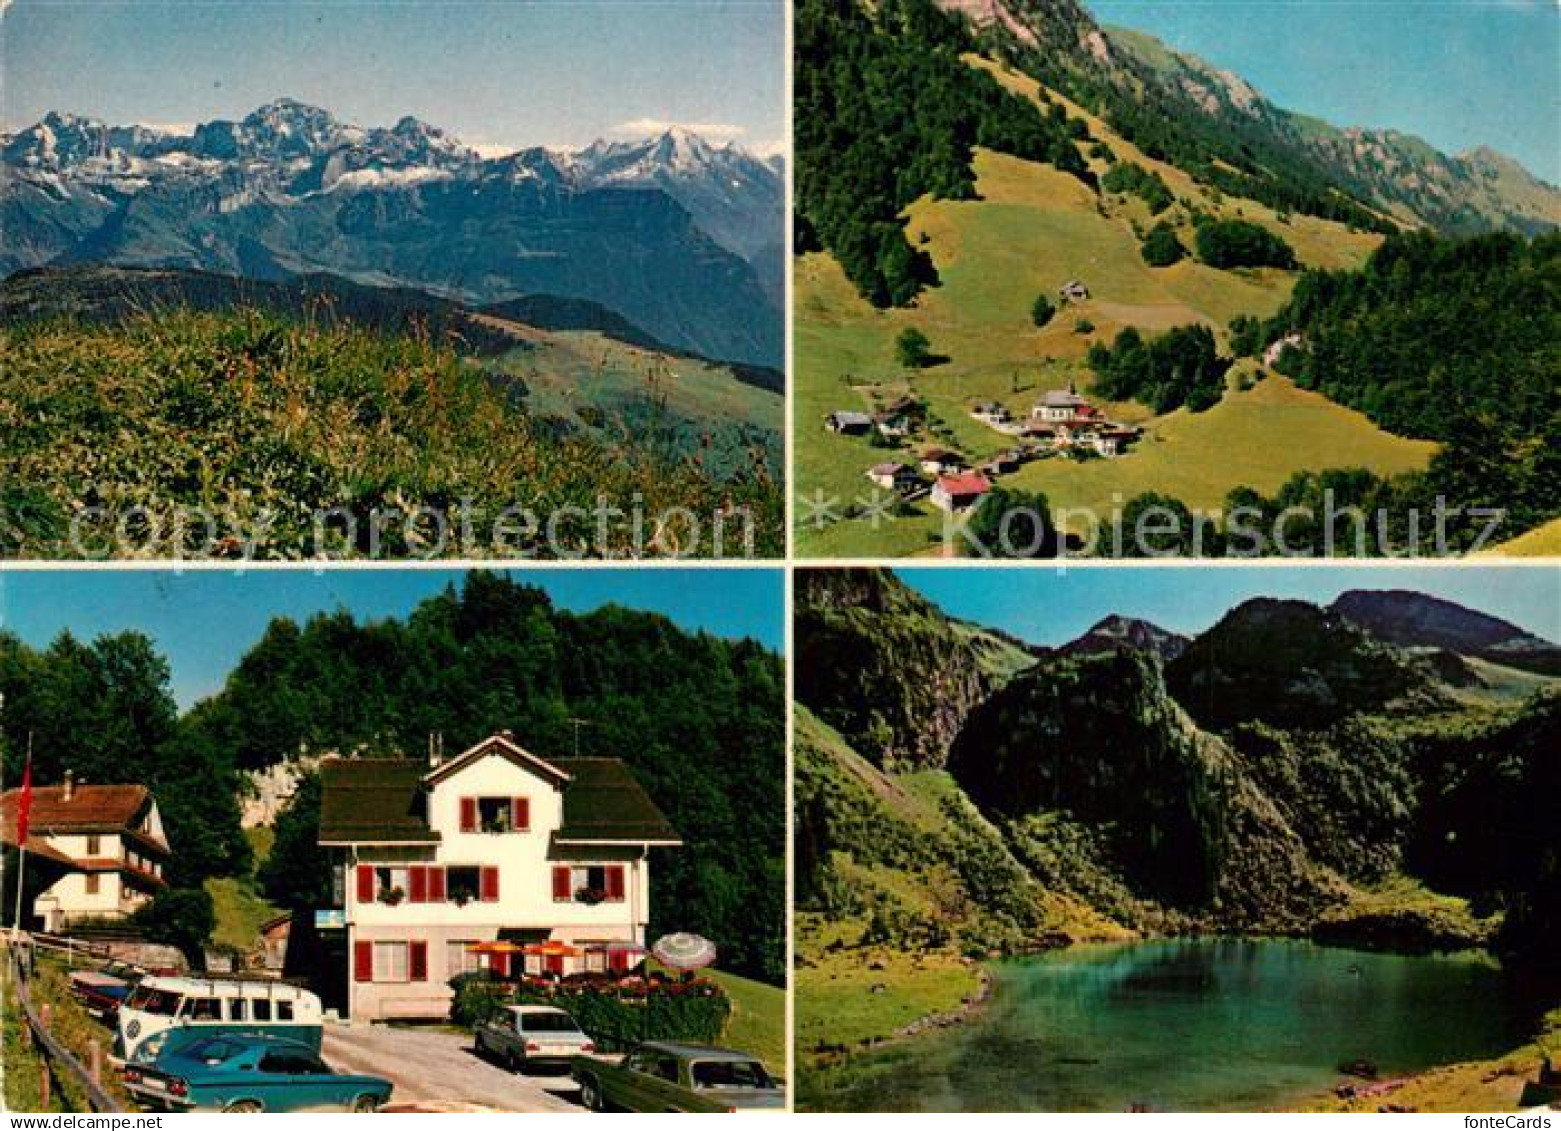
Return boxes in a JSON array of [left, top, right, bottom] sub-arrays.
[[896, 563, 1561, 644]]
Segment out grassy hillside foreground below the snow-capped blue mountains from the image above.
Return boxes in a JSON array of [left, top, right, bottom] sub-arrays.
[[0, 307, 782, 558]]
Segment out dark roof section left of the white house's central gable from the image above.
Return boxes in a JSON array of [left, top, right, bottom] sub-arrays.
[[320, 758, 439, 844]]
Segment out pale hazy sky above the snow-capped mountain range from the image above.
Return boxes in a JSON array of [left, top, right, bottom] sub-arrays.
[[0, 0, 785, 153]]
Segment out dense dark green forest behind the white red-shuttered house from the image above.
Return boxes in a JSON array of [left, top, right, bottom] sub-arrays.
[[0, 573, 785, 983]]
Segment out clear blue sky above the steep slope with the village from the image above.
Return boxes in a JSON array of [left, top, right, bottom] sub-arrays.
[[1085, 0, 1561, 183]]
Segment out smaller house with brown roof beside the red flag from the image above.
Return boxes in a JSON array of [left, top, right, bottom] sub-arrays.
[[0, 772, 170, 931]]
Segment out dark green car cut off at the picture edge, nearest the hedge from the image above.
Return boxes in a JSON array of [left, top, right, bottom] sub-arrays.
[[571, 1041, 785, 1112]]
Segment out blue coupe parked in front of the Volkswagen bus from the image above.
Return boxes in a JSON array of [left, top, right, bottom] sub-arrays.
[[125, 1033, 392, 1112]]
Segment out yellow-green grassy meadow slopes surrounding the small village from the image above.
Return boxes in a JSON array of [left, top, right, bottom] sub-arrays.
[[793, 66, 1435, 557]]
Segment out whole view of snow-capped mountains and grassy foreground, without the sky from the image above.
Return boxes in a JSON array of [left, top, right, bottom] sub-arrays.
[[0, 98, 785, 557]]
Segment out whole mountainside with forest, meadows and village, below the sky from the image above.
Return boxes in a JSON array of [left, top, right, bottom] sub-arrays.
[[793, 0, 1561, 558]]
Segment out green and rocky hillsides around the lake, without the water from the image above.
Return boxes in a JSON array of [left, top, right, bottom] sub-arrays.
[[795, 569, 1561, 1108]]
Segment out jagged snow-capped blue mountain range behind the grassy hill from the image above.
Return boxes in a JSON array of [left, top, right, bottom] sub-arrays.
[[0, 98, 785, 363]]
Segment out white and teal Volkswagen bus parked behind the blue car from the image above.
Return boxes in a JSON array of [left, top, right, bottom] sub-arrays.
[[114, 975, 325, 1062]]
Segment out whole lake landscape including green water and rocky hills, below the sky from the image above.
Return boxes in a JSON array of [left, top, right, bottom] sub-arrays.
[[795, 566, 1561, 1111]]
